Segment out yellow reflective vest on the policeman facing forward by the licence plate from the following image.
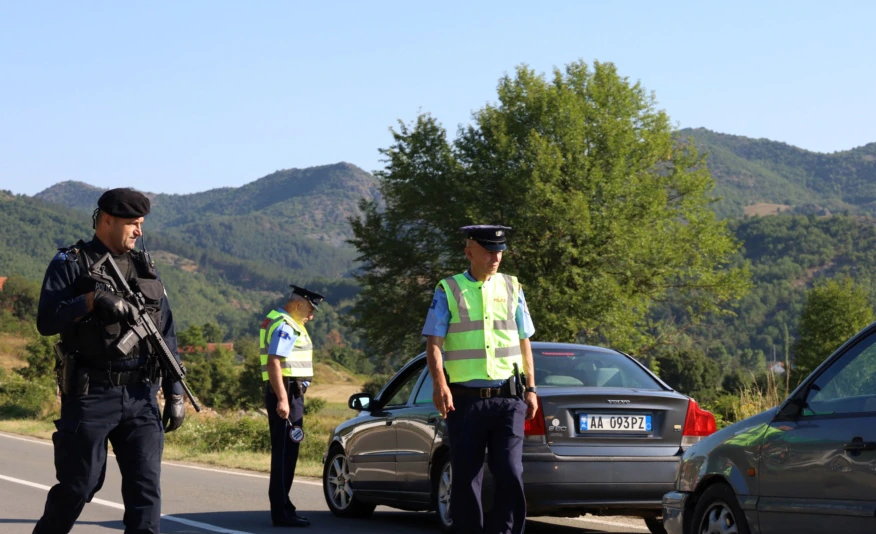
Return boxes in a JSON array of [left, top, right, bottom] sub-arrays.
[[438, 274, 523, 383]]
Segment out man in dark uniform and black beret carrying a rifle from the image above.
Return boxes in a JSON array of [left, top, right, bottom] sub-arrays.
[[33, 188, 185, 534]]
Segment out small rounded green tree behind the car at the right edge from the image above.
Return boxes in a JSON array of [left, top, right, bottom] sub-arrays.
[[791, 276, 873, 383]]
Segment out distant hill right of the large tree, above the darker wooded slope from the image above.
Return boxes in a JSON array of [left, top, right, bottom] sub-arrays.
[[678, 128, 876, 217]]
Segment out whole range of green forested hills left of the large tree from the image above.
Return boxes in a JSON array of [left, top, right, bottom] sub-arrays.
[[0, 163, 377, 336]]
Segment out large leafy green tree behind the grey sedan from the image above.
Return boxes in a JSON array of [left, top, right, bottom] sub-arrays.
[[351, 62, 748, 364]]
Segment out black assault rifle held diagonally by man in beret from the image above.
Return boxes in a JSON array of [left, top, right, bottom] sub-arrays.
[[89, 253, 201, 412]]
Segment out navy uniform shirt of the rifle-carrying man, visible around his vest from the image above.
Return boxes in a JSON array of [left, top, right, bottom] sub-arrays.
[[37, 237, 183, 396]]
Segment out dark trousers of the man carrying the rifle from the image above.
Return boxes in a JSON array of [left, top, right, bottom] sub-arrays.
[[33, 382, 164, 534]]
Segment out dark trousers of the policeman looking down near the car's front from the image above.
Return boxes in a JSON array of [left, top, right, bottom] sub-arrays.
[[265, 382, 304, 521]]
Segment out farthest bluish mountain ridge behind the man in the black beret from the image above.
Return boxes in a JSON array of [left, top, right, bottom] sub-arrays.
[[36, 163, 378, 284]]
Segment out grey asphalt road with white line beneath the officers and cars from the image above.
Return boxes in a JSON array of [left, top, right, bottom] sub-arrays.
[[0, 433, 648, 534]]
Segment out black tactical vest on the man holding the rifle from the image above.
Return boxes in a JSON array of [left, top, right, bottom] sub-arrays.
[[61, 241, 164, 369]]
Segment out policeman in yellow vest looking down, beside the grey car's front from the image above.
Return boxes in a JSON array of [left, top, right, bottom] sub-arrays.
[[259, 285, 325, 527]]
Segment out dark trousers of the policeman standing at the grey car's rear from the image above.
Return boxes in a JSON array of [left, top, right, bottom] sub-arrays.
[[447, 387, 526, 534]]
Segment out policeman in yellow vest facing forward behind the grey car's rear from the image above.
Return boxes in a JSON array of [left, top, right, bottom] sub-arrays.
[[423, 225, 537, 534]]
